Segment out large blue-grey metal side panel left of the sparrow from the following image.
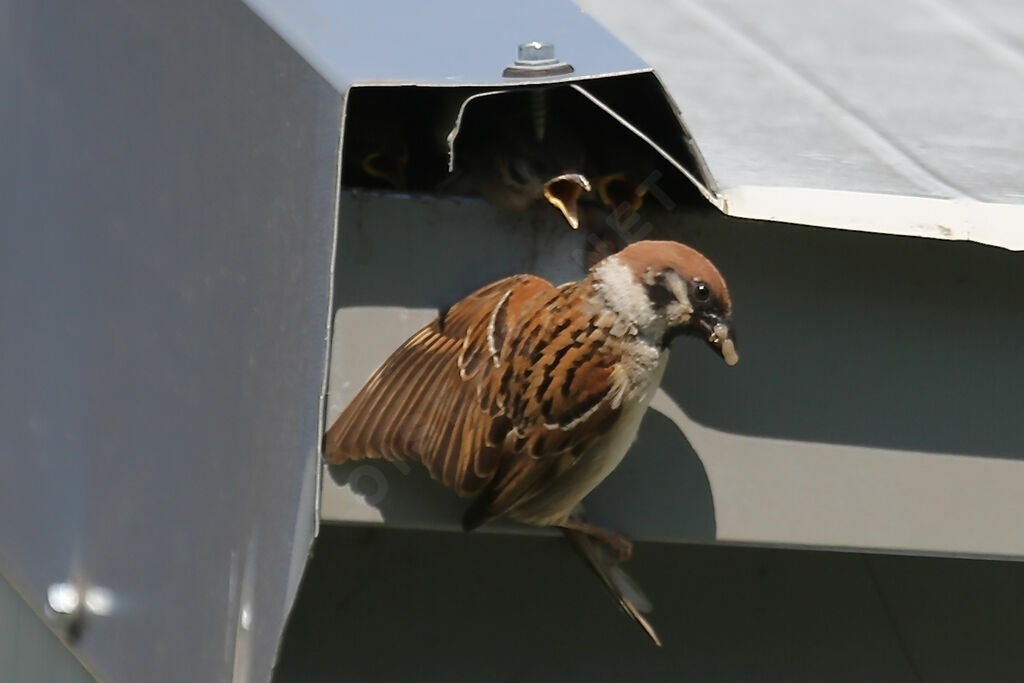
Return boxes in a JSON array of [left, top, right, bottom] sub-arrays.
[[0, 0, 341, 683]]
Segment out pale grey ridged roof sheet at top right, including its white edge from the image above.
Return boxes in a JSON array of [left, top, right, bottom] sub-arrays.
[[579, 0, 1024, 249]]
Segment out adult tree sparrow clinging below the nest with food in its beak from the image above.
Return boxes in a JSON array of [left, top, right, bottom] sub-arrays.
[[324, 242, 738, 544]]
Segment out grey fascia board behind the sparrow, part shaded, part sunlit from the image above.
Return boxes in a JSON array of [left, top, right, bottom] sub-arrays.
[[322, 194, 1024, 558]]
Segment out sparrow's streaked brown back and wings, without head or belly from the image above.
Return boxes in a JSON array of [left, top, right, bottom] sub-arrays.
[[324, 275, 621, 526]]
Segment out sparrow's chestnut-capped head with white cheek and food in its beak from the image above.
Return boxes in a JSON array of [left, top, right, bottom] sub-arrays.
[[591, 241, 739, 366]]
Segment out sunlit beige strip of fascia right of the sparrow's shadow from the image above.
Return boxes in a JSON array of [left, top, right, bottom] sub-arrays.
[[651, 389, 1024, 558]]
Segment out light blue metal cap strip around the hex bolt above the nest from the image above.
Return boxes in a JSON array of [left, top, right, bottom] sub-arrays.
[[245, 0, 648, 91]]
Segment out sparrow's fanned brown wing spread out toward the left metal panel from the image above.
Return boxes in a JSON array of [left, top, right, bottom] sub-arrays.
[[324, 275, 554, 496]]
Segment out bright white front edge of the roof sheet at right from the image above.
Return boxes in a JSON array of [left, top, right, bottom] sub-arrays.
[[721, 185, 1024, 251]]
